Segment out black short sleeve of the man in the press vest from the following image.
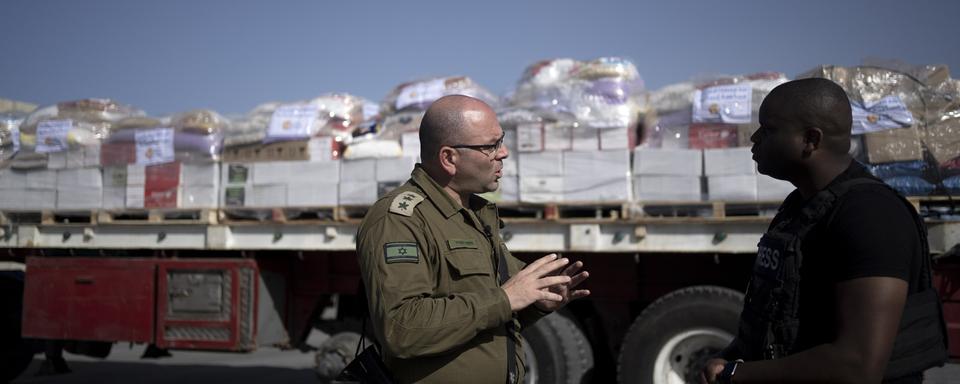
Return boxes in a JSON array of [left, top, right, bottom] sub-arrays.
[[826, 188, 921, 282]]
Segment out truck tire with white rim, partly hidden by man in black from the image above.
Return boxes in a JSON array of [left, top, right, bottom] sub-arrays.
[[617, 286, 743, 384]]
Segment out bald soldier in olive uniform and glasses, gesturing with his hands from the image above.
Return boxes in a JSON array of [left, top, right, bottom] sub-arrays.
[[357, 95, 589, 383]]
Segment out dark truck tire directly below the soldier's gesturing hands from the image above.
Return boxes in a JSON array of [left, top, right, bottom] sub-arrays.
[[523, 313, 593, 384]]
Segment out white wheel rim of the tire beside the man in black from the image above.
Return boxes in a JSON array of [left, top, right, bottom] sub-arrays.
[[653, 328, 733, 384]]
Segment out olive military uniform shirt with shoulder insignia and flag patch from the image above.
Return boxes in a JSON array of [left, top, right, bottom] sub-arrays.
[[357, 164, 546, 383]]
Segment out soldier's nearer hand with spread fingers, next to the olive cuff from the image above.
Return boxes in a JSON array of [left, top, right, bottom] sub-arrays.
[[500, 254, 571, 312]]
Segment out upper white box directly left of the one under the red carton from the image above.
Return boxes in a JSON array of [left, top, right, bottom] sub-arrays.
[[633, 148, 703, 177]]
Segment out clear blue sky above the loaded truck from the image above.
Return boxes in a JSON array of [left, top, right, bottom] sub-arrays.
[[0, 0, 960, 115]]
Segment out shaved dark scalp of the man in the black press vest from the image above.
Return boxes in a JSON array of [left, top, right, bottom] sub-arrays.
[[760, 78, 853, 155]]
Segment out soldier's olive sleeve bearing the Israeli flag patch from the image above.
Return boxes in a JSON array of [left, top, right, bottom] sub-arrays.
[[357, 208, 512, 358]]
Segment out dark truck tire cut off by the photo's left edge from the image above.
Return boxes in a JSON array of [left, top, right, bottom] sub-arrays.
[[0, 271, 35, 383]]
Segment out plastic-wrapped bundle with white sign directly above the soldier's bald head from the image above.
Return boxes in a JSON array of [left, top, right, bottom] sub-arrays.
[[380, 76, 500, 116]]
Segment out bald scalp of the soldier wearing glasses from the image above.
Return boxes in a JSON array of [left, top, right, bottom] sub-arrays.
[[420, 95, 494, 162]]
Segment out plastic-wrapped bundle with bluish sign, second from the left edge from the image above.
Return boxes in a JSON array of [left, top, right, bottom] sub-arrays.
[[13, 99, 145, 168]]
